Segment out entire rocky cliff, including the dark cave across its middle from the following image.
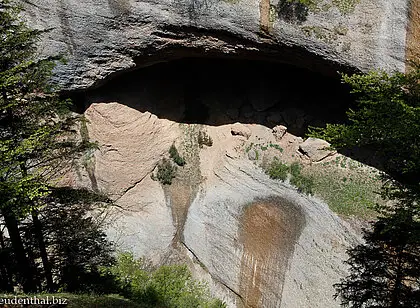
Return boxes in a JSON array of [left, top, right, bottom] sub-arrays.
[[22, 0, 419, 308]]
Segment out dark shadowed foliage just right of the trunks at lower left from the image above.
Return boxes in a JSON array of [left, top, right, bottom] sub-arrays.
[[37, 203, 115, 293]]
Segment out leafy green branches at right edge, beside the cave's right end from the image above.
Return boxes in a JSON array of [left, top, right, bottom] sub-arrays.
[[311, 65, 420, 185]]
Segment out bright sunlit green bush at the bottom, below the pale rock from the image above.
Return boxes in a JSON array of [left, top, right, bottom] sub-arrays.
[[104, 253, 226, 308]]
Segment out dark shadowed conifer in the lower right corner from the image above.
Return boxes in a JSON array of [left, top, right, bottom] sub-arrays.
[[335, 203, 420, 308]]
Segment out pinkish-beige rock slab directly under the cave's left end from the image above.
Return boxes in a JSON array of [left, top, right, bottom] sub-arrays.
[[85, 103, 179, 197]]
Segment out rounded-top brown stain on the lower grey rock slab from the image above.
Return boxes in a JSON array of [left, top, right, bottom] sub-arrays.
[[240, 198, 305, 308]]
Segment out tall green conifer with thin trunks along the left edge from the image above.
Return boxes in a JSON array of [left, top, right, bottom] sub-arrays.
[[0, 0, 93, 292]]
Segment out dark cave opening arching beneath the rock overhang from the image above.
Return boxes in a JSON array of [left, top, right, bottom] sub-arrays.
[[74, 58, 351, 135]]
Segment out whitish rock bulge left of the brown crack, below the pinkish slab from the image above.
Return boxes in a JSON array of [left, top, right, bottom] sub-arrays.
[[106, 177, 176, 264]]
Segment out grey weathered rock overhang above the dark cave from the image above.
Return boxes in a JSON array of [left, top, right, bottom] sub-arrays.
[[22, 0, 412, 90]]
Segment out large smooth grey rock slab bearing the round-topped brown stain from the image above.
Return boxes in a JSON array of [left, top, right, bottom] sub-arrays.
[[184, 158, 360, 308]]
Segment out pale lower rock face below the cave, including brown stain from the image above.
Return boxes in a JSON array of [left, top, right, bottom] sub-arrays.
[[80, 102, 360, 308]]
